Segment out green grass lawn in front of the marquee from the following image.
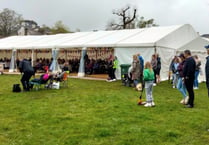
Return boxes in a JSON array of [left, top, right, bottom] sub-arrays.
[[0, 75, 209, 145]]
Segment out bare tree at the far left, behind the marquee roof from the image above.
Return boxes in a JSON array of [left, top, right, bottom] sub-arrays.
[[0, 8, 22, 37]]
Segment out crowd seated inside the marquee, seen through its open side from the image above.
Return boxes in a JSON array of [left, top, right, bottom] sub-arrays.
[[0, 58, 114, 75]]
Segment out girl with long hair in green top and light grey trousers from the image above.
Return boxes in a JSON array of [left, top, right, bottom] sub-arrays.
[[143, 62, 155, 107]]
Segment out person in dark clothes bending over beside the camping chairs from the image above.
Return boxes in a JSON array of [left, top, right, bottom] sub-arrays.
[[19, 59, 35, 91]]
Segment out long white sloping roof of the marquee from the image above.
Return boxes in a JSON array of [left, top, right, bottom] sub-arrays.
[[0, 24, 198, 49]]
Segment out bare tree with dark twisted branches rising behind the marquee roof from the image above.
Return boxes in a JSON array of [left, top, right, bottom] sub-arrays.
[[110, 6, 137, 30]]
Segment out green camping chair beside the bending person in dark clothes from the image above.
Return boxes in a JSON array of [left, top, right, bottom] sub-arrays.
[[29, 75, 52, 90]]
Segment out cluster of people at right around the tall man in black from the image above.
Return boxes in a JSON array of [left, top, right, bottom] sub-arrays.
[[170, 50, 204, 108]]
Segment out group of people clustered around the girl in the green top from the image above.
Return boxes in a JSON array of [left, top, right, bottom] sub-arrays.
[[130, 54, 161, 107]]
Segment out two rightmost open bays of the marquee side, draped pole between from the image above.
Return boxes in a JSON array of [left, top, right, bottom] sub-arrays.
[[58, 47, 114, 77]]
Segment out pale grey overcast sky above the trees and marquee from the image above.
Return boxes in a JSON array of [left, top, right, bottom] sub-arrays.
[[0, 0, 209, 34]]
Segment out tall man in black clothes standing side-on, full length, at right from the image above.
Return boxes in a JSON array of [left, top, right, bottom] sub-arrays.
[[183, 50, 196, 108]]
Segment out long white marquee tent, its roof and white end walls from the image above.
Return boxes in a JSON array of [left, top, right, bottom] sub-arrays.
[[0, 24, 205, 79]]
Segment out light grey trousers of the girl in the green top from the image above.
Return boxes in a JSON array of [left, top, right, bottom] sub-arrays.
[[145, 81, 154, 103]]
